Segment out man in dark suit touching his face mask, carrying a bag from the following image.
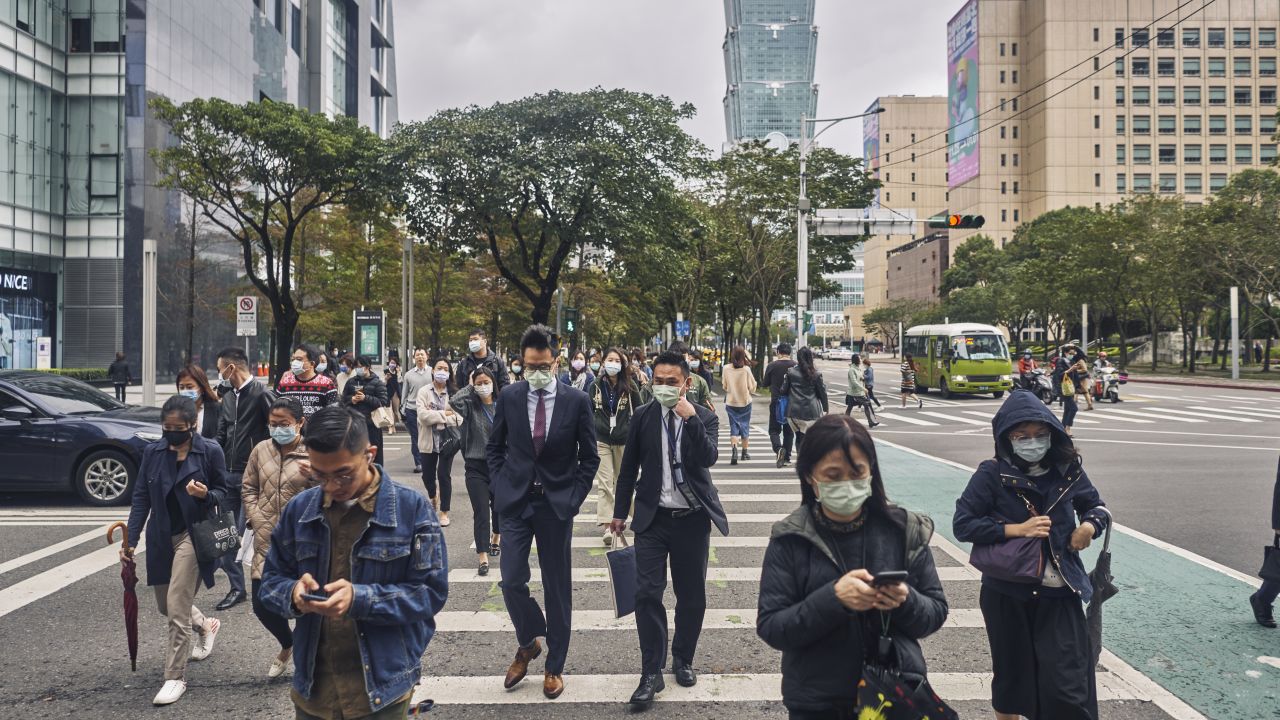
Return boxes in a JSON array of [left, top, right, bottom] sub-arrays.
[[611, 352, 728, 707]]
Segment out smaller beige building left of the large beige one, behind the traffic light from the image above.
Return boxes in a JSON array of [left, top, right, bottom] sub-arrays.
[[845, 95, 948, 337]]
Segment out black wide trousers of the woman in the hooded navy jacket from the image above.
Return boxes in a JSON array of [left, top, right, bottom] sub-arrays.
[[978, 585, 1098, 720]]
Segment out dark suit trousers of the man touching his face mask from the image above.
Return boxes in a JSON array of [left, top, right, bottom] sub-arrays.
[[636, 507, 712, 674]]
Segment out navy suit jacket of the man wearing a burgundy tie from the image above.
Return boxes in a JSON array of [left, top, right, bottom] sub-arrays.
[[485, 380, 600, 520]]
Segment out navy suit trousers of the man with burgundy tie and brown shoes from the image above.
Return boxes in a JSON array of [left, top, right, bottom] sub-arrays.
[[499, 496, 573, 675]]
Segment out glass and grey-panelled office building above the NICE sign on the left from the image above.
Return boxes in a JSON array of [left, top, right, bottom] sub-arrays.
[[0, 0, 397, 368]]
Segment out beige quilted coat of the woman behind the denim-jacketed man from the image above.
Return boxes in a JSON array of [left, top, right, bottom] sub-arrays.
[[241, 439, 314, 580]]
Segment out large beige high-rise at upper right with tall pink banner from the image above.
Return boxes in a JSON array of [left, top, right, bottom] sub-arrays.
[[947, 0, 1280, 245]]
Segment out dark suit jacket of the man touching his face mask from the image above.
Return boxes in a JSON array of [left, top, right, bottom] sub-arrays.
[[613, 400, 728, 536]]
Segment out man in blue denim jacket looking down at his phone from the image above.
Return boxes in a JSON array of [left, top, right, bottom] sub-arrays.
[[261, 405, 448, 720]]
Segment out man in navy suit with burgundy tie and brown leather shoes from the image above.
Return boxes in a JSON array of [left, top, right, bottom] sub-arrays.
[[485, 325, 600, 700]]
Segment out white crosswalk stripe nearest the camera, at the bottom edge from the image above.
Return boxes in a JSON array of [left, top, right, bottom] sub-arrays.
[[413, 670, 1151, 707]]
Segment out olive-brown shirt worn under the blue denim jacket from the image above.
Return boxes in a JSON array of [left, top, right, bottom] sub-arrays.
[[291, 471, 412, 720]]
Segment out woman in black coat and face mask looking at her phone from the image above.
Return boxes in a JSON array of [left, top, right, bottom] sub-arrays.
[[755, 415, 947, 719]]
